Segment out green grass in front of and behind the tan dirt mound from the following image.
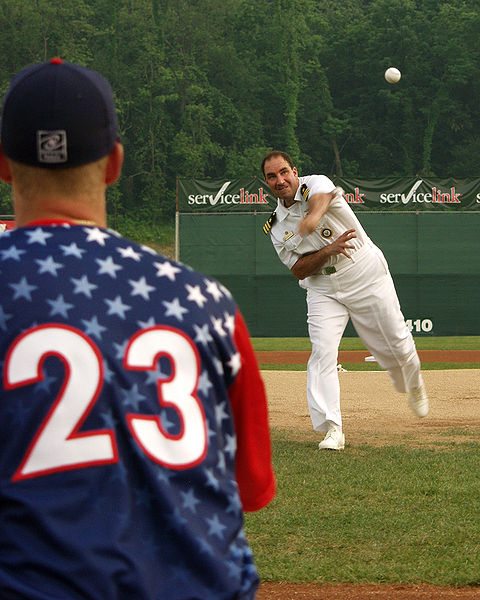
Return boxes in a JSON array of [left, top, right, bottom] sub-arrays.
[[245, 337, 480, 587]]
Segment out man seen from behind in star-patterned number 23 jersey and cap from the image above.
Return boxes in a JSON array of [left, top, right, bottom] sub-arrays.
[[0, 59, 275, 600]]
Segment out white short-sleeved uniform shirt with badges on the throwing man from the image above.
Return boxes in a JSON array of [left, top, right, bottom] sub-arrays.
[[270, 175, 373, 288]]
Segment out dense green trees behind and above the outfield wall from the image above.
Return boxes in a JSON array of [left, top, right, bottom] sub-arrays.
[[0, 0, 480, 225]]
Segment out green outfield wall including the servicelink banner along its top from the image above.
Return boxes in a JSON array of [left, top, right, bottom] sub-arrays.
[[176, 177, 480, 337]]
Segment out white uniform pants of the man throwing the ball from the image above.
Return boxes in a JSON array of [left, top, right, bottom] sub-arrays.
[[307, 246, 422, 431]]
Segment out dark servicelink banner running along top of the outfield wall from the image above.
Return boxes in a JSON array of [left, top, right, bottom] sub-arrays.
[[177, 177, 480, 213]]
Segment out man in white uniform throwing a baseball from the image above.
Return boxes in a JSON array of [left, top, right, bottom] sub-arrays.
[[262, 151, 428, 450]]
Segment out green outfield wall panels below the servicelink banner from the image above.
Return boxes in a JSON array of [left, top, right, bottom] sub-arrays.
[[179, 212, 480, 337]]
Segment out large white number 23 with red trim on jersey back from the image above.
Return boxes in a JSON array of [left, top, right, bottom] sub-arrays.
[[3, 324, 208, 481]]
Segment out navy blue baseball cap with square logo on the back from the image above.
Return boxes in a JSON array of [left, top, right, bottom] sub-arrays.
[[1, 58, 118, 169]]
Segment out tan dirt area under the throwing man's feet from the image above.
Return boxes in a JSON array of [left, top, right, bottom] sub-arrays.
[[262, 369, 480, 445]]
